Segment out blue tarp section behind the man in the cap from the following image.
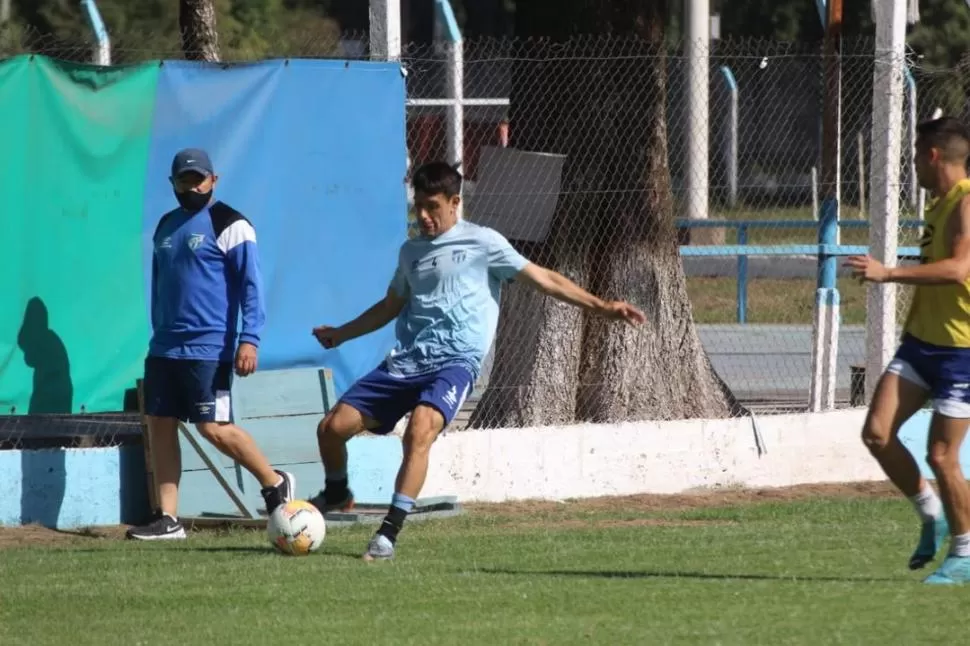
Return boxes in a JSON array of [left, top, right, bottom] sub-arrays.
[[142, 60, 407, 393]]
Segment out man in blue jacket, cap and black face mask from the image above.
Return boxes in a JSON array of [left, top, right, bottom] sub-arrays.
[[127, 149, 295, 540]]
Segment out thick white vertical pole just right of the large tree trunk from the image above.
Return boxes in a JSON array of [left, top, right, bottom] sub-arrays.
[[684, 0, 711, 225]]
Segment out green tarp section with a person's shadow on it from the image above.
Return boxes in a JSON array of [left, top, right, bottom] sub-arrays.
[[0, 56, 159, 414]]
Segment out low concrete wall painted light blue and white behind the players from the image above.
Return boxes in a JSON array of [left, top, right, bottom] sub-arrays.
[[0, 410, 970, 528]]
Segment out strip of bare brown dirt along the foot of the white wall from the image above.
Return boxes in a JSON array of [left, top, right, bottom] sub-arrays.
[[463, 481, 900, 516]]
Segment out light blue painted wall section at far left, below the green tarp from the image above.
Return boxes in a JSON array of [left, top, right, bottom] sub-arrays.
[[0, 446, 148, 529]]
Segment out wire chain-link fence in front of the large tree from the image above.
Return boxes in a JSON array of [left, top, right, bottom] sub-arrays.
[[0, 27, 963, 438]]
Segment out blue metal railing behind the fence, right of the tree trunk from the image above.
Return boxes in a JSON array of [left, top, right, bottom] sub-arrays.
[[677, 220, 923, 324]]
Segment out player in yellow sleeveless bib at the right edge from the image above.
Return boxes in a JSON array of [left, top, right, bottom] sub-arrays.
[[846, 118, 970, 584]]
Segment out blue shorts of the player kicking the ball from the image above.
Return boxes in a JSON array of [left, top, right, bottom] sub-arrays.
[[340, 364, 475, 435]]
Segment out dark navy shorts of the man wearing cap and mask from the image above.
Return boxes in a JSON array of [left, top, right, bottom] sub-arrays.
[[144, 357, 232, 423]]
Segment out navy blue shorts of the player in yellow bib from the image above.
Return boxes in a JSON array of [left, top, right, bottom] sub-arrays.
[[886, 334, 970, 419]]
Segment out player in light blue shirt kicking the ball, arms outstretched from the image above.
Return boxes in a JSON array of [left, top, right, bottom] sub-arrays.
[[311, 162, 644, 561]]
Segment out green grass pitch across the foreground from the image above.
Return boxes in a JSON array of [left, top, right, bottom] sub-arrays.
[[0, 485, 970, 646]]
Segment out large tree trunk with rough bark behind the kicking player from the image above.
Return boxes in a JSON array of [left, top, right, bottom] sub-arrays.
[[472, 0, 741, 426]]
